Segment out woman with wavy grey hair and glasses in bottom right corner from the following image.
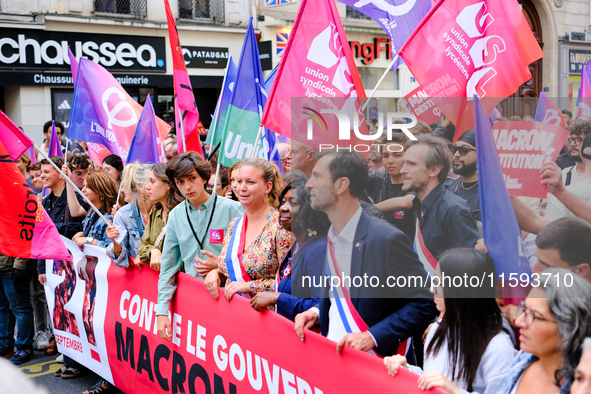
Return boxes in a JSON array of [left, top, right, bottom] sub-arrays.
[[501, 268, 591, 394]]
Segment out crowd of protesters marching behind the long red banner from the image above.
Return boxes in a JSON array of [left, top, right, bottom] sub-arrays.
[[0, 111, 591, 394]]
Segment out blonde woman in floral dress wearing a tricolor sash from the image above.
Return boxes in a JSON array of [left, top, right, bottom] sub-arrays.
[[205, 158, 293, 301]]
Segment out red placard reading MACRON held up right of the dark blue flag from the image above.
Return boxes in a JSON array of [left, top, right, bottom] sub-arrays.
[[492, 121, 569, 198]]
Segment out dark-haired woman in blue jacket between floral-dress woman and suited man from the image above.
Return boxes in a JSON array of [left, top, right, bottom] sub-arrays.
[[250, 170, 330, 320]]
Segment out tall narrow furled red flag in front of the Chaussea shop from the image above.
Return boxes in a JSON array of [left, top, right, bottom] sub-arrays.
[[164, 0, 203, 157]]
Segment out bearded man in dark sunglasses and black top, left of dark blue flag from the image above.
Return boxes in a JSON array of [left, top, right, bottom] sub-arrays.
[[447, 129, 481, 222]]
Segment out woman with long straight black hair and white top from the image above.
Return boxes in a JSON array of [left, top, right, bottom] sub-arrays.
[[384, 249, 515, 394]]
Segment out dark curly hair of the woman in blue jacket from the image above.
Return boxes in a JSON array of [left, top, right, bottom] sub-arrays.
[[291, 174, 330, 235]]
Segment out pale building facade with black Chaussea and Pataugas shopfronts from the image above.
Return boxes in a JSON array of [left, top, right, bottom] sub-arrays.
[[0, 0, 252, 143]]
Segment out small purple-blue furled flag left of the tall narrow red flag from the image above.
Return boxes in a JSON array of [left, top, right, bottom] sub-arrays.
[[126, 93, 164, 164]]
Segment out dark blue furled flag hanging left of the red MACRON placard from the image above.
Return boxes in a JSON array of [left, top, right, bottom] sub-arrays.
[[474, 96, 531, 296]]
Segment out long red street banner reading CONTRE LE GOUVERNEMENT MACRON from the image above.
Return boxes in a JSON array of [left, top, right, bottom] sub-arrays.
[[46, 240, 444, 394]]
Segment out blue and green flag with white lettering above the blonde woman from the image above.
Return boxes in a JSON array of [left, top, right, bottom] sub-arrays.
[[218, 18, 281, 167]]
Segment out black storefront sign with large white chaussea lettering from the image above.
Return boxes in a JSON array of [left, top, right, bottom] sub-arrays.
[[0, 29, 166, 73]]
